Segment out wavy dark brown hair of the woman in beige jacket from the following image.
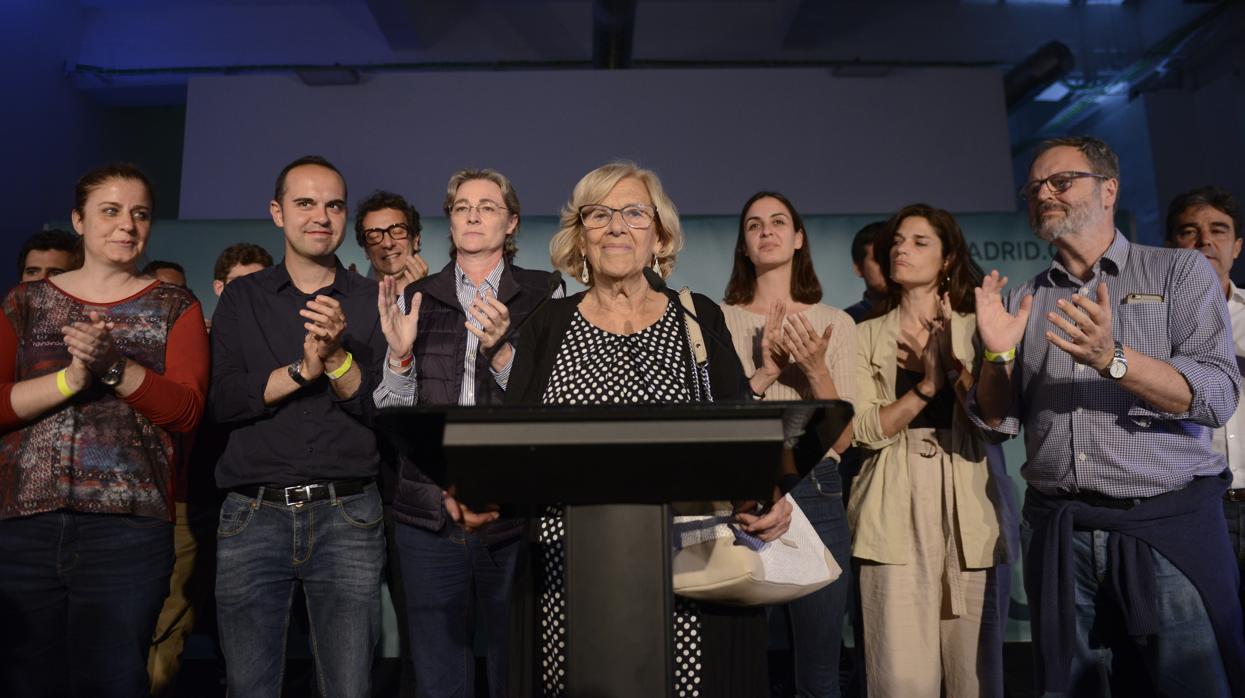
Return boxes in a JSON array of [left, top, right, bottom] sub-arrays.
[[873, 204, 977, 315]]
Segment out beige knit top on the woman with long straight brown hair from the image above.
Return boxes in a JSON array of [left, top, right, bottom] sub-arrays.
[[722, 304, 857, 460]]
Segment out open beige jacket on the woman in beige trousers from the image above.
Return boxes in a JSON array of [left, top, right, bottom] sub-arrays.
[[848, 309, 1006, 570]]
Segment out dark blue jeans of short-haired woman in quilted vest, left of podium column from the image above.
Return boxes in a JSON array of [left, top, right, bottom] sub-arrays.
[[397, 523, 522, 698]]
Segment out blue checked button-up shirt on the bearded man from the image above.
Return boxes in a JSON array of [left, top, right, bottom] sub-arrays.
[[969, 231, 1241, 498]]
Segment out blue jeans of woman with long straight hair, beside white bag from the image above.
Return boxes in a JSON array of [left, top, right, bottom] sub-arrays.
[[776, 460, 852, 698]]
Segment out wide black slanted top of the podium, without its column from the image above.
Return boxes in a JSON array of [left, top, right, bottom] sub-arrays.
[[378, 401, 852, 508]]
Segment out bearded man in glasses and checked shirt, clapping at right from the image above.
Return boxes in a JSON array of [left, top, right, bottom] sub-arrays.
[[970, 137, 1245, 697]]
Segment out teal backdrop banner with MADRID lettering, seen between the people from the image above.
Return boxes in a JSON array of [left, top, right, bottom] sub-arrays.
[[133, 207, 1052, 641]]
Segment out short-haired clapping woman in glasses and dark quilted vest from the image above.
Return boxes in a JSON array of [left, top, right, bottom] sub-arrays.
[[374, 169, 562, 698]]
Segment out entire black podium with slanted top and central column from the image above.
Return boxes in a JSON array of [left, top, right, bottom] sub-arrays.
[[380, 401, 852, 698]]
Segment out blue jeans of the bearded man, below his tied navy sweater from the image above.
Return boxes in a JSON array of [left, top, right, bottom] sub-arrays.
[[1021, 516, 1231, 698]]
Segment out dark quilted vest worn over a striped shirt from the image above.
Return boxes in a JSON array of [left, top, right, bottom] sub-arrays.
[[393, 261, 552, 541]]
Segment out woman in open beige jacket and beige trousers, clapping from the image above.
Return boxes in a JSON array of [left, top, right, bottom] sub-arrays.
[[848, 204, 1006, 698]]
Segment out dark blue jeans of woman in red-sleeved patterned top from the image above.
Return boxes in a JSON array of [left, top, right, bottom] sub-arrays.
[[0, 511, 173, 698]]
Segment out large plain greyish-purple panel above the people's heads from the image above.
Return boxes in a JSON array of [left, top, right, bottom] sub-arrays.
[[179, 67, 1017, 219]]
